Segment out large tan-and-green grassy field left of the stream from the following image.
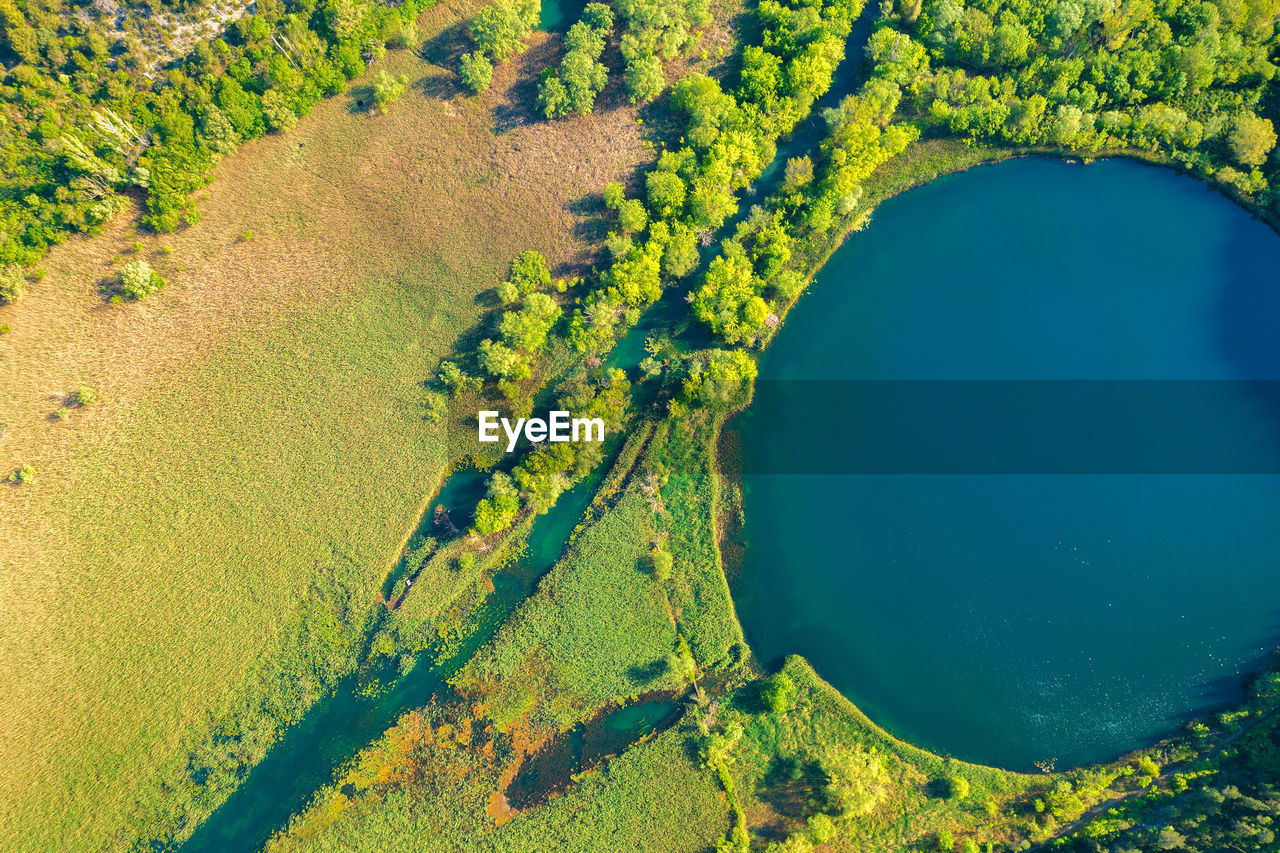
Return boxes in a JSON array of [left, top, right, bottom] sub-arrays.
[[0, 3, 646, 835]]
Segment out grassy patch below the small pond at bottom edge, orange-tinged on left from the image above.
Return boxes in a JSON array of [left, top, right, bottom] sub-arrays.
[[266, 701, 728, 853]]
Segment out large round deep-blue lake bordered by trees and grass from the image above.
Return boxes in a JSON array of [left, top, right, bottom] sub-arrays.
[[735, 159, 1280, 770]]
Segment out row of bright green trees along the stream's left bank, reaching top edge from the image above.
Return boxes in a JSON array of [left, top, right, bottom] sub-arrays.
[[568, 0, 860, 353]]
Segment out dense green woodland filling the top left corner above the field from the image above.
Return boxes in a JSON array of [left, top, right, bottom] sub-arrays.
[[0, 0, 433, 275]]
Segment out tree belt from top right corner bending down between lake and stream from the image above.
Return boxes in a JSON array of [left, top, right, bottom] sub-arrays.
[[692, 0, 1280, 347]]
